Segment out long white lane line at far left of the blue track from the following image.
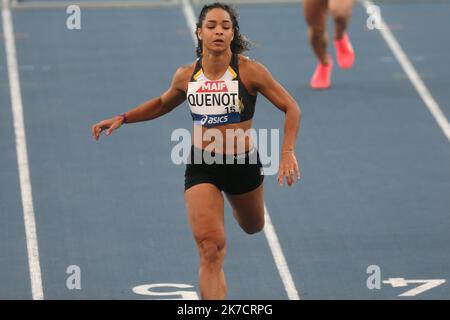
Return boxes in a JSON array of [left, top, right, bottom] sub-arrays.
[[2, 0, 44, 300]]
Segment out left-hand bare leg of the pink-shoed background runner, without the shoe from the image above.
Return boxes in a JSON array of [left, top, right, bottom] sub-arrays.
[[303, 0, 328, 64]]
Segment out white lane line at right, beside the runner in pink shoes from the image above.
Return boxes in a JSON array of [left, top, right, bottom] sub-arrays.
[[361, 0, 450, 142]]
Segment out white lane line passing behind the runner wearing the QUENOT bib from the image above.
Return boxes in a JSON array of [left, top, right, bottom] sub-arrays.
[[181, 0, 300, 300]]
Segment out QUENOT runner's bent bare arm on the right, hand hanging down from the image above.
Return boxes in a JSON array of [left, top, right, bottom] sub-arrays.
[[249, 61, 302, 186]]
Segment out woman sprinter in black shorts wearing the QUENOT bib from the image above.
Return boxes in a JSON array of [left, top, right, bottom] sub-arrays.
[[92, 3, 301, 299]]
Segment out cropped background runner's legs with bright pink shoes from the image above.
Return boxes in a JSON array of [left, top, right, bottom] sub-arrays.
[[303, 0, 355, 89]]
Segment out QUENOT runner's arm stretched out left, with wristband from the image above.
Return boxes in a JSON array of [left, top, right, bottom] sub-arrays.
[[92, 67, 190, 140]]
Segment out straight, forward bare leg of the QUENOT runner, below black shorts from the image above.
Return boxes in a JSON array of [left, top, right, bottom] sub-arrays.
[[184, 183, 227, 299]]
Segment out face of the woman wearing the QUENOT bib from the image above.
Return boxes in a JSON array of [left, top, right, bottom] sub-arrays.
[[198, 8, 234, 53]]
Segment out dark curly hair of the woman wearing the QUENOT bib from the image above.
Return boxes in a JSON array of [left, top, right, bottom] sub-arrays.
[[195, 2, 251, 57]]
